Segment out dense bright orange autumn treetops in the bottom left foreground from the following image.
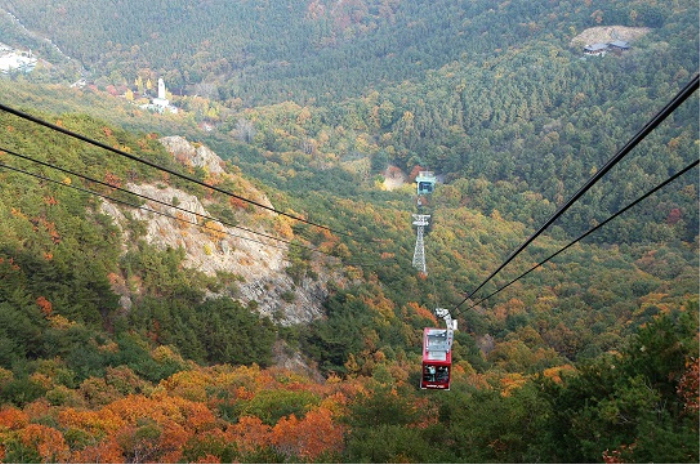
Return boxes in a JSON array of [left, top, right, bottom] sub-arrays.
[[0, 366, 353, 462]]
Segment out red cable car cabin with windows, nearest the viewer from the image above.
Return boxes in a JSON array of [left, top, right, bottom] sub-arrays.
[[420, 327, 454, 390]]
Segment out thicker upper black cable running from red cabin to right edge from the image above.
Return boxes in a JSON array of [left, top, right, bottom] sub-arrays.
[[452, 74, 700, 312]]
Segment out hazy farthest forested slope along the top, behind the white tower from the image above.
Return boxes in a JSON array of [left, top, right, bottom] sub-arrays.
[[0, 0, 684, 105]]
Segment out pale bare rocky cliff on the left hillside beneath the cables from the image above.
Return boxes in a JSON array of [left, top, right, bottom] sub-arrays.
[[102, 137, 330, 325]]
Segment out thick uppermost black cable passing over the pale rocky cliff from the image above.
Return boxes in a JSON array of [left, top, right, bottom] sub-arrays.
[[0, 103, 355, 239]]
